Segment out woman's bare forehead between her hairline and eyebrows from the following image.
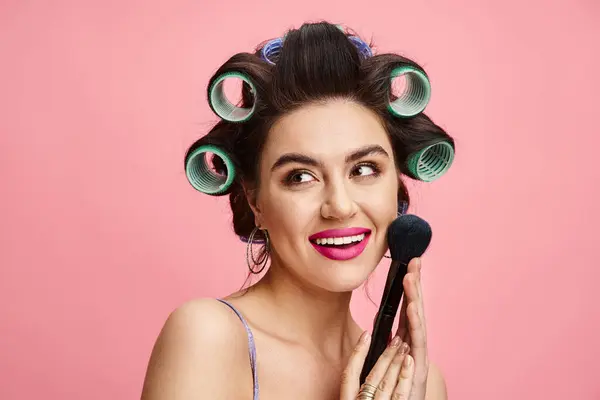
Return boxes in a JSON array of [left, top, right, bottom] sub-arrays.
[[263, 100, 392, 162]]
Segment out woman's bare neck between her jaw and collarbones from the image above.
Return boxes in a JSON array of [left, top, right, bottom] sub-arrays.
[[248, 260, 361, 361]]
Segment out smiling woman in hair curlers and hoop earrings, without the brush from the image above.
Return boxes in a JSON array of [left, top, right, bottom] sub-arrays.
[[142, 23, 454, 400]]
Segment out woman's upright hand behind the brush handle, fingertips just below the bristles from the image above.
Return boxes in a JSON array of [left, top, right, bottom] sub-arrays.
[[396, 258, 429, 400]]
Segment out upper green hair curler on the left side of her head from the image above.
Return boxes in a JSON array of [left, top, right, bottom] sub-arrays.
[[209, 72, 256, 122]]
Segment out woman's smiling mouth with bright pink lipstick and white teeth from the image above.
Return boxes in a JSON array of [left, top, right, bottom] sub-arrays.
[[308, 228, 371, 261]]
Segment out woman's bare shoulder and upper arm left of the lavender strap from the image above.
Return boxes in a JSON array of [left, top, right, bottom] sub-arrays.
[[141, 299, 252, 400]]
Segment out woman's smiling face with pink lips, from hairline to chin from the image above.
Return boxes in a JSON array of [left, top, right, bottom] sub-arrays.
[[253, 100, 399, 292]]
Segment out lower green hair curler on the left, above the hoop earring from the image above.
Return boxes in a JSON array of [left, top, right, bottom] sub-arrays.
[[185, 145, 235, 196]]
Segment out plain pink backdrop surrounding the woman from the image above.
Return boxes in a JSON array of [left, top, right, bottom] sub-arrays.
[[0, 0, 600, 400]]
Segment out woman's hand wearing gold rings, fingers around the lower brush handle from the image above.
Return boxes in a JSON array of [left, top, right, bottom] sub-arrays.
[[340, 332, 415, 400]]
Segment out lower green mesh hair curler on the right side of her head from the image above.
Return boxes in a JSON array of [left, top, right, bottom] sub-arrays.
[[406, 141, 454, 182]]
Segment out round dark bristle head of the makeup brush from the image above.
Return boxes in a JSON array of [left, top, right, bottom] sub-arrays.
[[387, 214, 431, 264]]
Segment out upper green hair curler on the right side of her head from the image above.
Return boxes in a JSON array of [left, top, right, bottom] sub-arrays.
[[388, 65, 431, 118]]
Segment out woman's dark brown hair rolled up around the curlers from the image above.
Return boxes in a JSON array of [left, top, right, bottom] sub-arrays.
[[186, 22, 454, 244]]
